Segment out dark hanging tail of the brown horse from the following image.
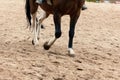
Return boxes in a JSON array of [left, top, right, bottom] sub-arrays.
[[25, 0, 31, 26]]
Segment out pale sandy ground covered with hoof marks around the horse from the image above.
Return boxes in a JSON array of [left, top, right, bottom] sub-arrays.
[[0, 0, 120, 80]]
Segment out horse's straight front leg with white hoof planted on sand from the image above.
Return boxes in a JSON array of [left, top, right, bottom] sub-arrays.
[[68, 11, 80, 57]]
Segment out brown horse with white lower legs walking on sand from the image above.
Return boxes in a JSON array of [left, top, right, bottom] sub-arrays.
[[25, 0, 85, 56]]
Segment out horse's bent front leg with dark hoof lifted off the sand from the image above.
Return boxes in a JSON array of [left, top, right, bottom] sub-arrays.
[[44, 13, 61, 50]]
